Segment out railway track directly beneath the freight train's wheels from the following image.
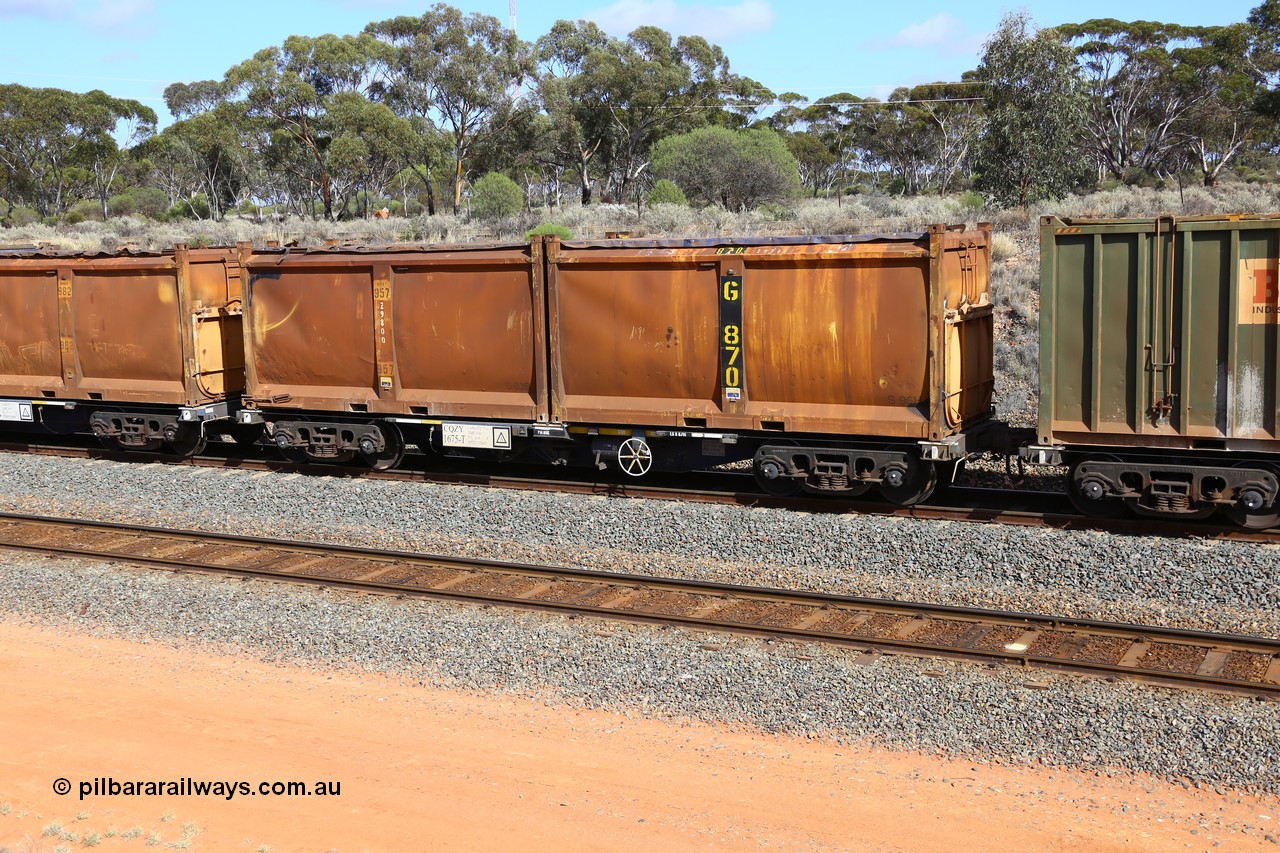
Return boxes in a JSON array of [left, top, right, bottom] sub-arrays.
[[0, 437, 1280, 544]]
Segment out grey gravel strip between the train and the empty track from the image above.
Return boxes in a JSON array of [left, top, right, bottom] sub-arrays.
[[0, 453, 1280, 637]]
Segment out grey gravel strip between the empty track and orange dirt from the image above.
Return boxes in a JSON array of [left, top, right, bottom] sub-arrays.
[[0, 556, 1280, 793]]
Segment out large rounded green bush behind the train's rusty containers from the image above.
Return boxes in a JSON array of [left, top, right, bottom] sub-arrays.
[[652, 127, 800, 210]]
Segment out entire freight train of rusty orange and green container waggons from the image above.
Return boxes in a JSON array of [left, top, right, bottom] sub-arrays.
[[0, 216, 1280, 528]]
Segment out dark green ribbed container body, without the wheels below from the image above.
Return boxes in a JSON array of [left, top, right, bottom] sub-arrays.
[[1039, 216, 1280, 450]]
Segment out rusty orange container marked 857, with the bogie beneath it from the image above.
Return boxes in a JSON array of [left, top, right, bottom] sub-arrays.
[[241, 242, 548, 467]]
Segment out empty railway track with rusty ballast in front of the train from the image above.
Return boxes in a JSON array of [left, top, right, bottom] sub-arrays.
[[0, 514, 1280, 699]]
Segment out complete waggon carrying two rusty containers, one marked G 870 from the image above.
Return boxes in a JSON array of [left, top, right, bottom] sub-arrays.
[[241, 227, 993, 503]]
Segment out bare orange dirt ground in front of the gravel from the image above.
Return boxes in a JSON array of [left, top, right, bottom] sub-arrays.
[[0, 622, 1280, 853]]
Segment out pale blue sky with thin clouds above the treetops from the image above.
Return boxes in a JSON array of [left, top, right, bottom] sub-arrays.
[[0, 0, 1261, 124]]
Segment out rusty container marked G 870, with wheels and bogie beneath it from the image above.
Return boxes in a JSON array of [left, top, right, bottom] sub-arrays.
[[547, 225, 993, 502]]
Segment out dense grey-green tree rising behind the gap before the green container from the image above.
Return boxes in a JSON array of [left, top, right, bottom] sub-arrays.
[[977, 13, 1089, 207]]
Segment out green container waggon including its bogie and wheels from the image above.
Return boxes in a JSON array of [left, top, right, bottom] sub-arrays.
[[1024, 215, 1280, 528]]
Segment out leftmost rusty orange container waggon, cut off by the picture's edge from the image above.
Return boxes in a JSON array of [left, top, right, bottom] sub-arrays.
[[0, 246, 244, 453]]
